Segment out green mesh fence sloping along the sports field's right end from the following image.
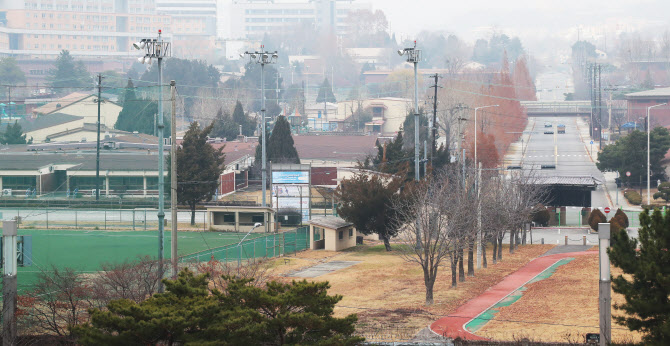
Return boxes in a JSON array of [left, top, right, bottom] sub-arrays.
[[180, 227, 309, 262]]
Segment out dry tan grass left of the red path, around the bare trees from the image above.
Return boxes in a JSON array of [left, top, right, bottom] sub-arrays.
[[272, 245, 554, 335]]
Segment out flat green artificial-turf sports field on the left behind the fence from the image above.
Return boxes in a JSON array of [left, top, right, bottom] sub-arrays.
[[13, 229, 265, 290]]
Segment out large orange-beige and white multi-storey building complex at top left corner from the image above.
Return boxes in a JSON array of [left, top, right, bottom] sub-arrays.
[[0, 0, 216, 58]]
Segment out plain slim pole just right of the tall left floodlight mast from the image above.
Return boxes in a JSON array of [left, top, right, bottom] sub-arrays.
[[170, 81, 179, 280]]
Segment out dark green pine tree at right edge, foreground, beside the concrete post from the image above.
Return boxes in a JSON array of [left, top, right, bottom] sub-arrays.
[[608, 209, 670, 345]]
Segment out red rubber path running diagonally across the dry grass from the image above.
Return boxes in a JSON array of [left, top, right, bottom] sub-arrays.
[[430, 251, 598, 340]]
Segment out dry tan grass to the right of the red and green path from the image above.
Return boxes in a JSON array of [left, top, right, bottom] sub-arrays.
[[477, 254, 641, 342]]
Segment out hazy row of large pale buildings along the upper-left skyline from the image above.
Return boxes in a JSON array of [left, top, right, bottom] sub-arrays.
[[0, 0, 371, 82]]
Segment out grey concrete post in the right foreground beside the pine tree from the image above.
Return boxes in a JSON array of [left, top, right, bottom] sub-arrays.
[[598, 223, 612, 346]]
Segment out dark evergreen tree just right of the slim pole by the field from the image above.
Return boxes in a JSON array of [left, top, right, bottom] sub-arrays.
[[177, 122, 225, 225]]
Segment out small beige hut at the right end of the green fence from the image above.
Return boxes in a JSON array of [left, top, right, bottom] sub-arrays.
[[309, 216, 357, 251]]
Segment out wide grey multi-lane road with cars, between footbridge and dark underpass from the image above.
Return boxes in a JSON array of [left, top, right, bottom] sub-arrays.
[[523, 117, 609, 207]]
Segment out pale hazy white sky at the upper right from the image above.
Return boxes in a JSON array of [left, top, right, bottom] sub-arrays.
[[370, 0, 670, 40]]
